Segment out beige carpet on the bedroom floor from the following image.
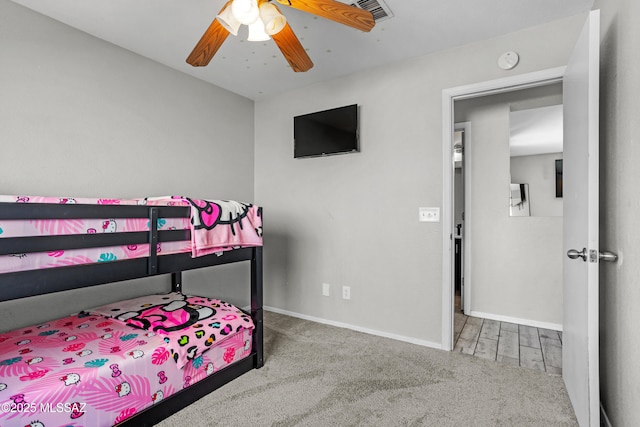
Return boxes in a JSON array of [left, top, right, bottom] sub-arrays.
[[160, 313, 577, 427]]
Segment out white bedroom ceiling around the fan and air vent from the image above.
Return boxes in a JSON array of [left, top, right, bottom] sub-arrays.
[[13, 0, 594, 99]]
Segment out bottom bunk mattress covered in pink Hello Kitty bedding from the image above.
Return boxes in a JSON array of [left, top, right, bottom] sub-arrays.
[[0, 292, 254, 427]]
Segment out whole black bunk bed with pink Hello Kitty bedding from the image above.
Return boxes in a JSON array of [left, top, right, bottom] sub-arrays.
[[0, 196, 264, 427]]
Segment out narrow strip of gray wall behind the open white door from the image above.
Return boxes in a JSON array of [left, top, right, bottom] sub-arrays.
[[594, 0, 640, 426]]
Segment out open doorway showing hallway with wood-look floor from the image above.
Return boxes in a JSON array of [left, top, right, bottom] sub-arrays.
[[453, 83, 563, 374]]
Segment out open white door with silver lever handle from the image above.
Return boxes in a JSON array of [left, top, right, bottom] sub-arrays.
[[562, 10, 600, 427]]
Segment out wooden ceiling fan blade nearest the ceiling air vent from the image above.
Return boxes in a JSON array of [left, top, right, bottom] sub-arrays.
[[278, 0, 375, 32]]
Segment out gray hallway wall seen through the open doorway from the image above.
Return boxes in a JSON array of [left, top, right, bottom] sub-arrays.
[[455, 85, 563, 329]]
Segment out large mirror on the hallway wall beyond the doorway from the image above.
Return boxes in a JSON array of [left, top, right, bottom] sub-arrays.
[[509, 104, 563, 217]]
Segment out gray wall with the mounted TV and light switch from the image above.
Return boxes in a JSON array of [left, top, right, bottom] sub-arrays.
[[255, 15, 584, 345]]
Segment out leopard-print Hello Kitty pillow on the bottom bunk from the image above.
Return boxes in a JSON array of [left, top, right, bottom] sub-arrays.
[[87, 292, 254, 368]]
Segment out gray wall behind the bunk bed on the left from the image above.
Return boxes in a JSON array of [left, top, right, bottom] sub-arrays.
[[0, 0, 254, 329]]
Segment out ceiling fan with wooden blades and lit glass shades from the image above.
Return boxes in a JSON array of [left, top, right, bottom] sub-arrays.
[[187, 0, 375, 72]]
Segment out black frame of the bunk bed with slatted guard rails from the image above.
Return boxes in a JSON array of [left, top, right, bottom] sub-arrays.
[[0, 202, 264, 426]]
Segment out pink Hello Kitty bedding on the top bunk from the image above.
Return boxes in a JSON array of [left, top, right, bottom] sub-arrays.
[[0, 196, 262, 273]]
